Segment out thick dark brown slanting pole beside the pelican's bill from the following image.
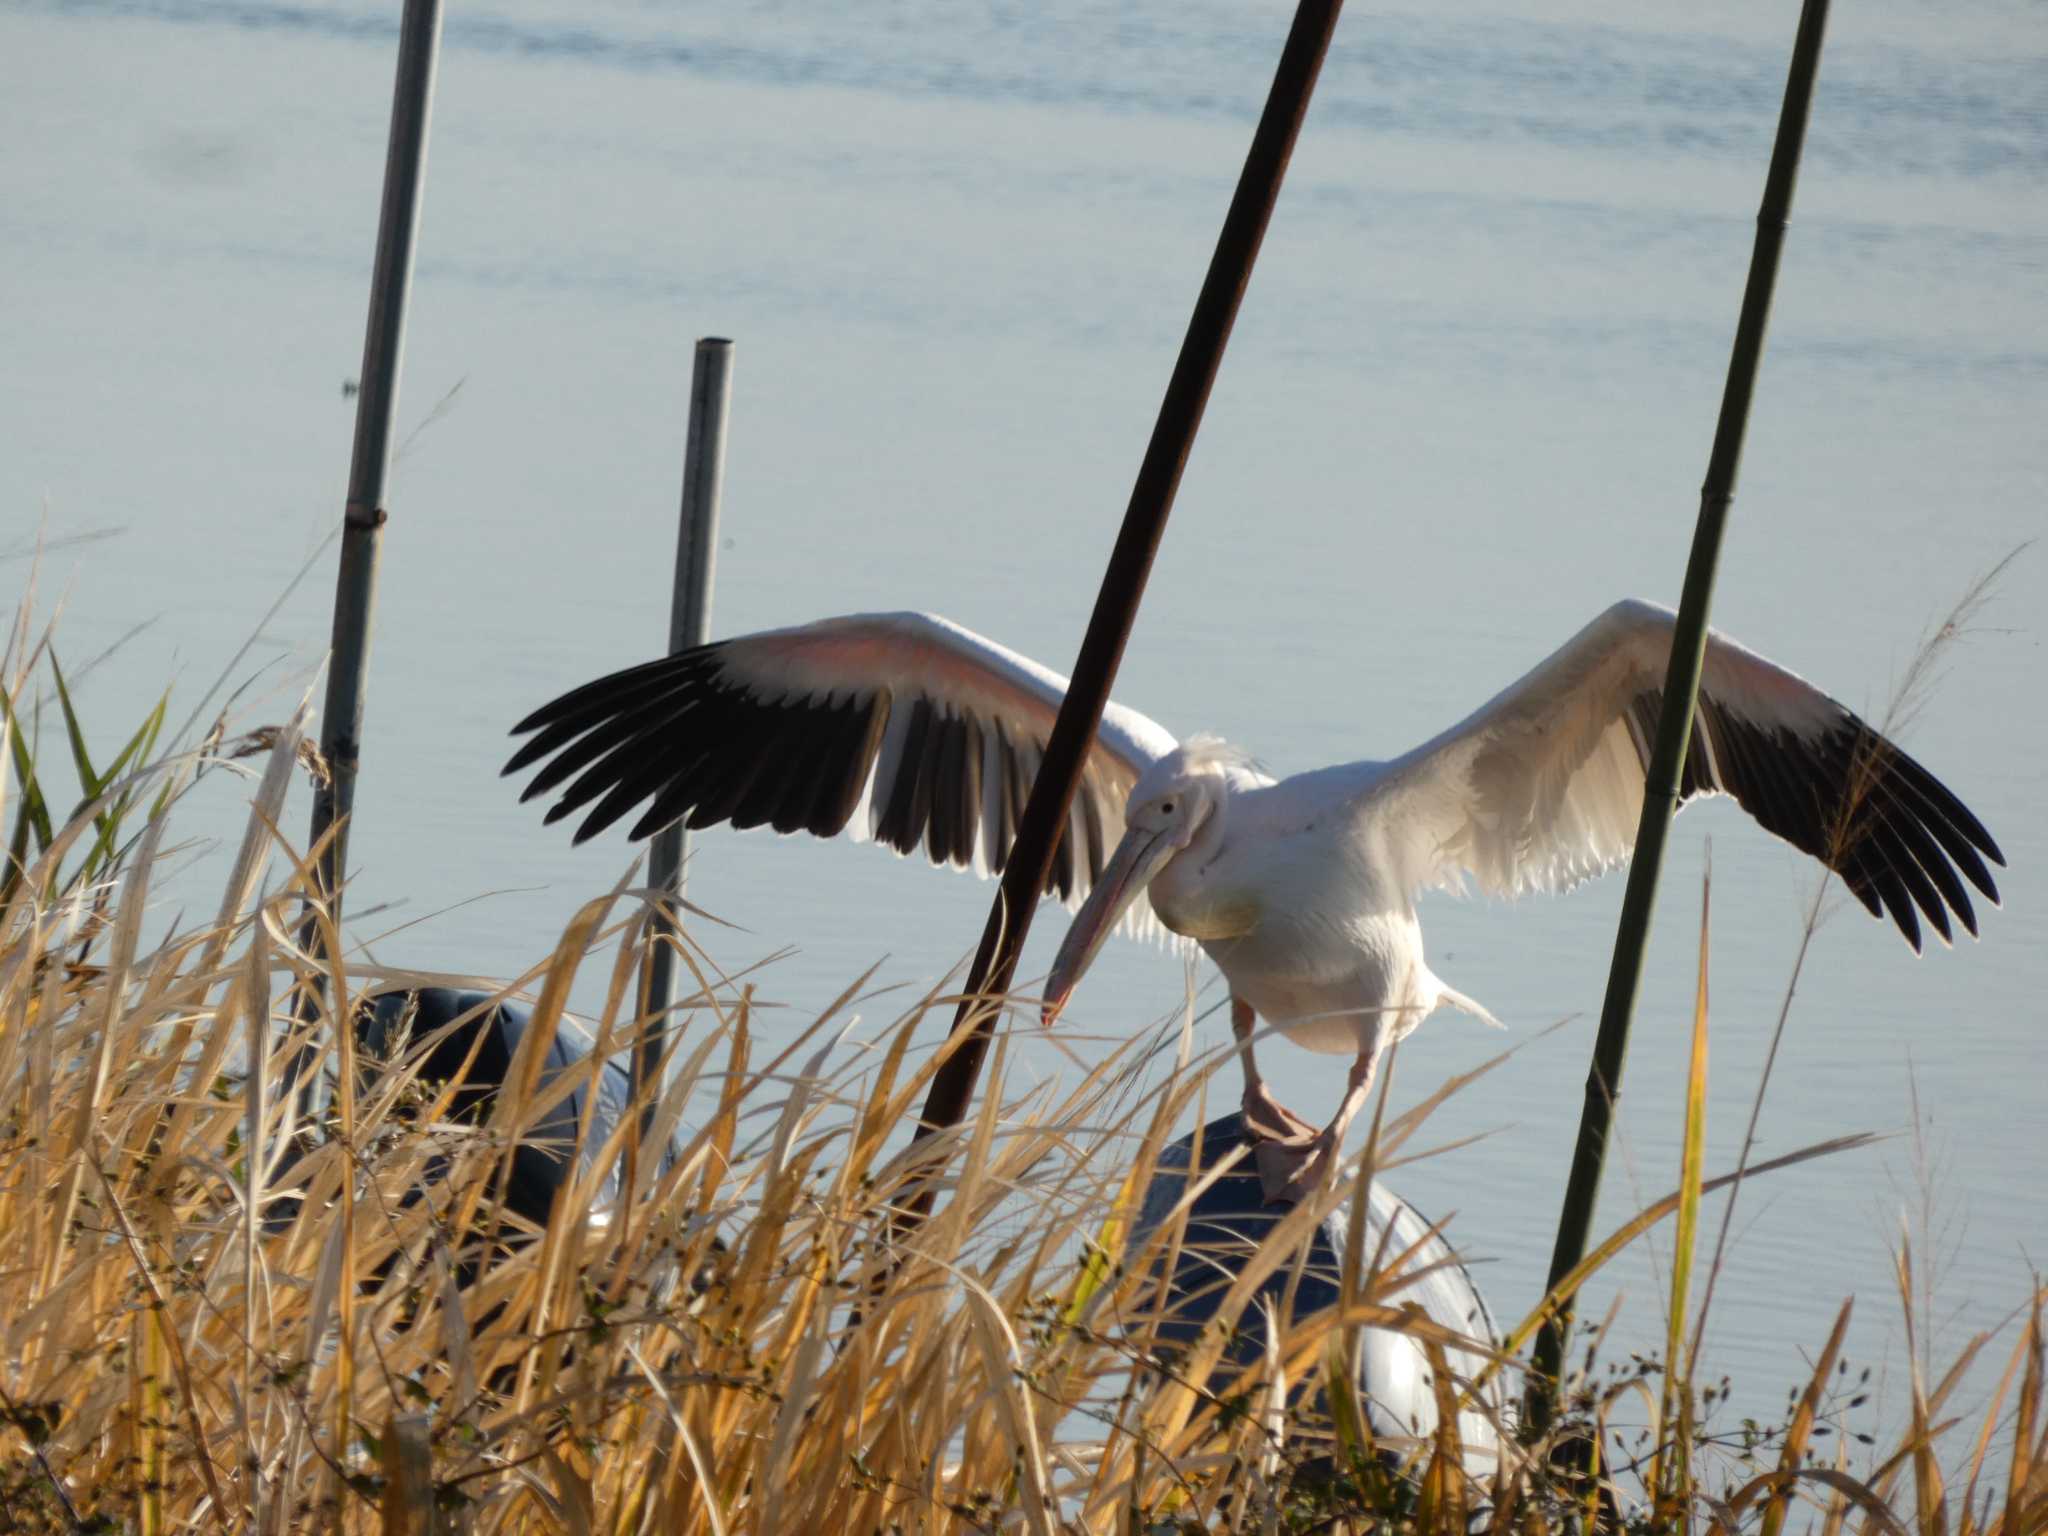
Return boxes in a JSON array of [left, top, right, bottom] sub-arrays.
[[911, 0, 1343, 1179]]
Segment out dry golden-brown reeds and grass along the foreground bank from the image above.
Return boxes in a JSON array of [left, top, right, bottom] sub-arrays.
[[0, 618, 2048, 1536]]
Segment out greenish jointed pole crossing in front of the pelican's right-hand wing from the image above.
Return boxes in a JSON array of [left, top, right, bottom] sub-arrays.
[[1526, 0, 1827, 1434]]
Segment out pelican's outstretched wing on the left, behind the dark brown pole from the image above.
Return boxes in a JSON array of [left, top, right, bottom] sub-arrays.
[[506, 612, 1176, 903]]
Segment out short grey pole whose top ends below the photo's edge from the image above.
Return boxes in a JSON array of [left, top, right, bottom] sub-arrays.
[[633, 336, 733, 1137]]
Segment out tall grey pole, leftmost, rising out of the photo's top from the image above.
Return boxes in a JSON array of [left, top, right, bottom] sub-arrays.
[[285, 0, 440, 1092]]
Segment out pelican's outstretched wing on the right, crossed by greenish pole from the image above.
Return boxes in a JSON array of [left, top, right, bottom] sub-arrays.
[[1358, 602, 2005, 950]]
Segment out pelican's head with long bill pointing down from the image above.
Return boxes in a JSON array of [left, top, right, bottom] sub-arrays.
[[1042, 735, 1257, 1024]]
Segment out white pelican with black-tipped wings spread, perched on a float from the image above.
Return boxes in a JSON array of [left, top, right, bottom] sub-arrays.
[[506, 600, 2005, 1200]]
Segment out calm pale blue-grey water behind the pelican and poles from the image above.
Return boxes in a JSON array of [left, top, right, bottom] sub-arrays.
[[12, 0, 2048, 1466]]
